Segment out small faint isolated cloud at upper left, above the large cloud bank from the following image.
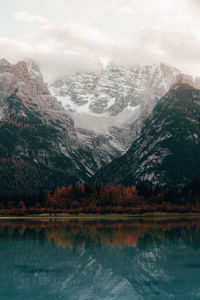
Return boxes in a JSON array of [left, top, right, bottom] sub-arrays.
[[13, 11, 47, 25]]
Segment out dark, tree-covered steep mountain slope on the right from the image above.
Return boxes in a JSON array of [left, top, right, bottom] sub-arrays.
[[92, 83, 200, 187]]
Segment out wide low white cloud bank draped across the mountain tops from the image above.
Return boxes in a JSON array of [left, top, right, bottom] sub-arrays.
[[0, 20, 200, 81]]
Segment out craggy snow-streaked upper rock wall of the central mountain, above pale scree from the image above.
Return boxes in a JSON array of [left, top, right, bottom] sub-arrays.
[[51, 64, 180, 115]]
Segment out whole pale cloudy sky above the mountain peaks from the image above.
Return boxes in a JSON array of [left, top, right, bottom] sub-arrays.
[[0, 0, 200, 82]]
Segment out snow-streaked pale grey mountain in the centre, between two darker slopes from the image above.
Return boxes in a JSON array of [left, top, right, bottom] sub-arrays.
[[50, 64, 197, 158]]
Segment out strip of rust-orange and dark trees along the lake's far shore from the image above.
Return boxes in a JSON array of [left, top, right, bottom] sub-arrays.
[[0, 182, 200, 215]]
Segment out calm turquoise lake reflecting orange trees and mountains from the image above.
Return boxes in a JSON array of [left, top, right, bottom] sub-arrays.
[[0, 218, 200, 300]]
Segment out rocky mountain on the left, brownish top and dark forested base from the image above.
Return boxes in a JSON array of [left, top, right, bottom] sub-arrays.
[[0, 60, 99, 192]]
